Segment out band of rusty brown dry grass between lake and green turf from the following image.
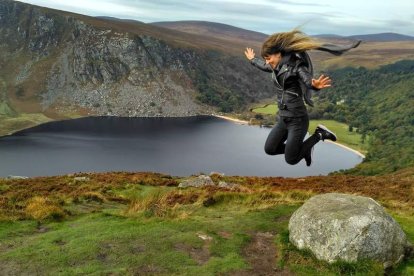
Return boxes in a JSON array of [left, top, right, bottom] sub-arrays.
[[0, 168, 414, 219]]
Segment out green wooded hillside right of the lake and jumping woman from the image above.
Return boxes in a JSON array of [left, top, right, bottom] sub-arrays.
[[310, 61, 414, 174]]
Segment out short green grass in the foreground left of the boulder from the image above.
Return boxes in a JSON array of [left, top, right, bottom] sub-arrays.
[[0, 203, 292, 275]]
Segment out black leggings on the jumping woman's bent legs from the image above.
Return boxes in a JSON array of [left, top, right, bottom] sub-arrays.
[[265, 115, 320, 165]]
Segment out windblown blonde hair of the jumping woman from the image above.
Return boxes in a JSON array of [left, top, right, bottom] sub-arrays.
[[261, 29, 322, 58]]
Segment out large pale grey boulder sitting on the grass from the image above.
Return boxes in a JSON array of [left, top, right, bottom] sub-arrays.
[[289, 193, 412, 267]]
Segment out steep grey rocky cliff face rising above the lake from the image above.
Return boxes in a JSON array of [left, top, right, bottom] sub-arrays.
[[0, 0, 272, 119]]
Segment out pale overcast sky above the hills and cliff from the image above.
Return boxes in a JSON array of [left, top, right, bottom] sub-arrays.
[[17, 0, 414, 36]]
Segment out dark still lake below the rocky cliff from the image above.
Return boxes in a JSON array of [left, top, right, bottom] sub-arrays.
[[0, 116, 362, 177]]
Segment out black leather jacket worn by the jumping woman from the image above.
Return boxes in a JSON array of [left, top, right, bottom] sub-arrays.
[[250, 54, 316, 117]]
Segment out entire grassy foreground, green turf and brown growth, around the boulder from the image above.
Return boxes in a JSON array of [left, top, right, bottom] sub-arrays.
[[0, 169, 414, 275]]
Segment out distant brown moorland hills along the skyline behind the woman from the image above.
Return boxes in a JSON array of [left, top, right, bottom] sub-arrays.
[[151, 21, 414, 71]]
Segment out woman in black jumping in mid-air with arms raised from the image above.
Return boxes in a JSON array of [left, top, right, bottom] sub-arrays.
[[244, 29, 360, 166]]
